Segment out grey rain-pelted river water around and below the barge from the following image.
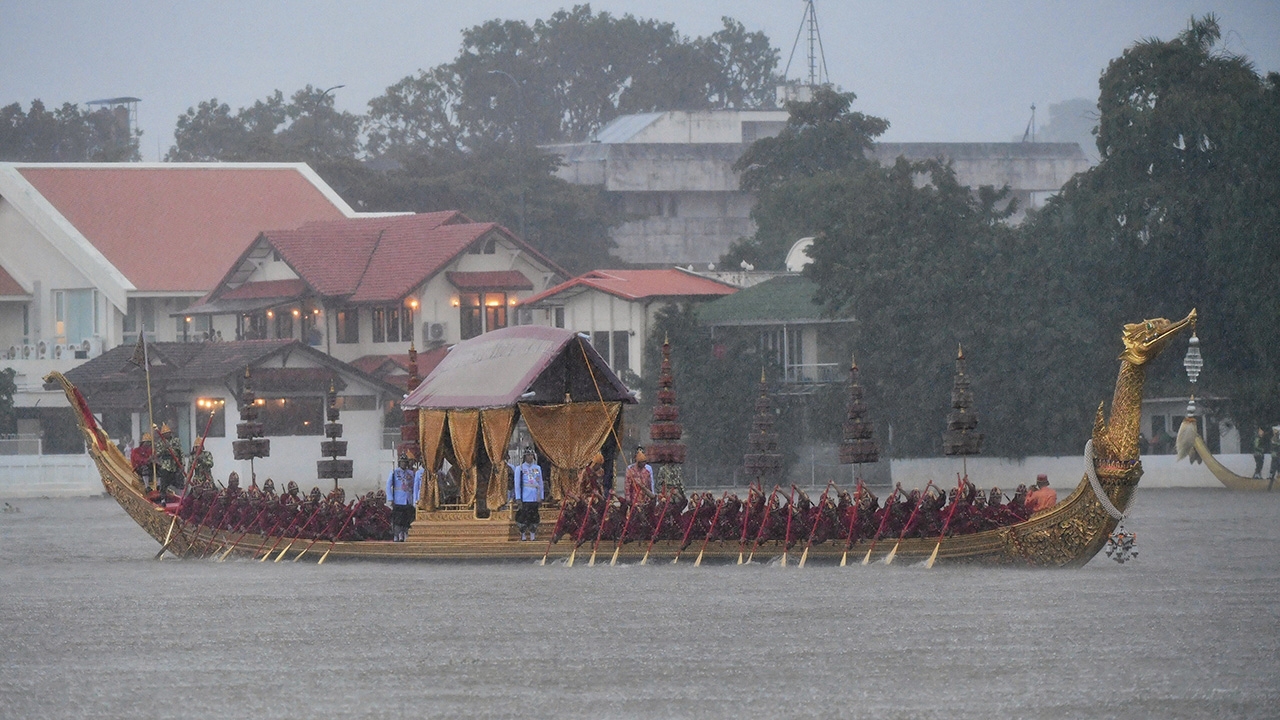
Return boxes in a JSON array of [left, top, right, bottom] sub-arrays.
[[0, 489, 1280, 719]]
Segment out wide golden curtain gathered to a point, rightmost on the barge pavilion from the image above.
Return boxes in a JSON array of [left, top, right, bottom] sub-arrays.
[[520, 402, 622, 501]]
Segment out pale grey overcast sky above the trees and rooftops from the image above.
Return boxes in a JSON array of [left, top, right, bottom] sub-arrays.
[[0, 0, 1280, 160]]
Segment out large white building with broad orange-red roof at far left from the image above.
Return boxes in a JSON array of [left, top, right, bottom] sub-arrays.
[[0, 163, 371, 354]]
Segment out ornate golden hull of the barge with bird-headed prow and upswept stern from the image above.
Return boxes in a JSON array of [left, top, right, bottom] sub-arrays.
[[46, 310, 1196, 568]]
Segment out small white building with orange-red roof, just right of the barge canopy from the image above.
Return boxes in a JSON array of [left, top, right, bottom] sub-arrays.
[[520, 268, 737, 375]]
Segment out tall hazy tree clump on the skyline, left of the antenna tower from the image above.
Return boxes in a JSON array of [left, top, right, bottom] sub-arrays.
[[369, 5, 778, 158]]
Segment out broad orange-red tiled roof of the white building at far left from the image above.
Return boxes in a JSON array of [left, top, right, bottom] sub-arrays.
[[17, 163, 346, 292]]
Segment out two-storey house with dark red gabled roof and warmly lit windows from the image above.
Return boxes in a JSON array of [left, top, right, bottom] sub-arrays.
[[183, 211, 566, 368]]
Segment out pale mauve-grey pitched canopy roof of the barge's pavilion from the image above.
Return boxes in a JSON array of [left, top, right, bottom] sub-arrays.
[[403, 325, 635, 409]]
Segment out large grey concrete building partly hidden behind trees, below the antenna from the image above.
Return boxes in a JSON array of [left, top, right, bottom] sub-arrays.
[[545, 110, 1089, 270]]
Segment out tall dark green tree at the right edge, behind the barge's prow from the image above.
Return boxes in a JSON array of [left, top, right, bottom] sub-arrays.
[[1028, 15, 1280, 427]]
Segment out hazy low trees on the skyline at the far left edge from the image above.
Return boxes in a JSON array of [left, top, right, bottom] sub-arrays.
[[0, 100, 142, 163]]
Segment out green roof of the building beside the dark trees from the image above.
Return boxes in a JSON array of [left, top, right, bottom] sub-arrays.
[[698, 274, 854, 325]]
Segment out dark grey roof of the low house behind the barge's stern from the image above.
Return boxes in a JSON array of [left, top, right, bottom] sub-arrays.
[[57, 340, 403, 407]]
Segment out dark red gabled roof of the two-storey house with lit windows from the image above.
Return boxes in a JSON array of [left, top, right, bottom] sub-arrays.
[[203, 210, 566, 304]]
